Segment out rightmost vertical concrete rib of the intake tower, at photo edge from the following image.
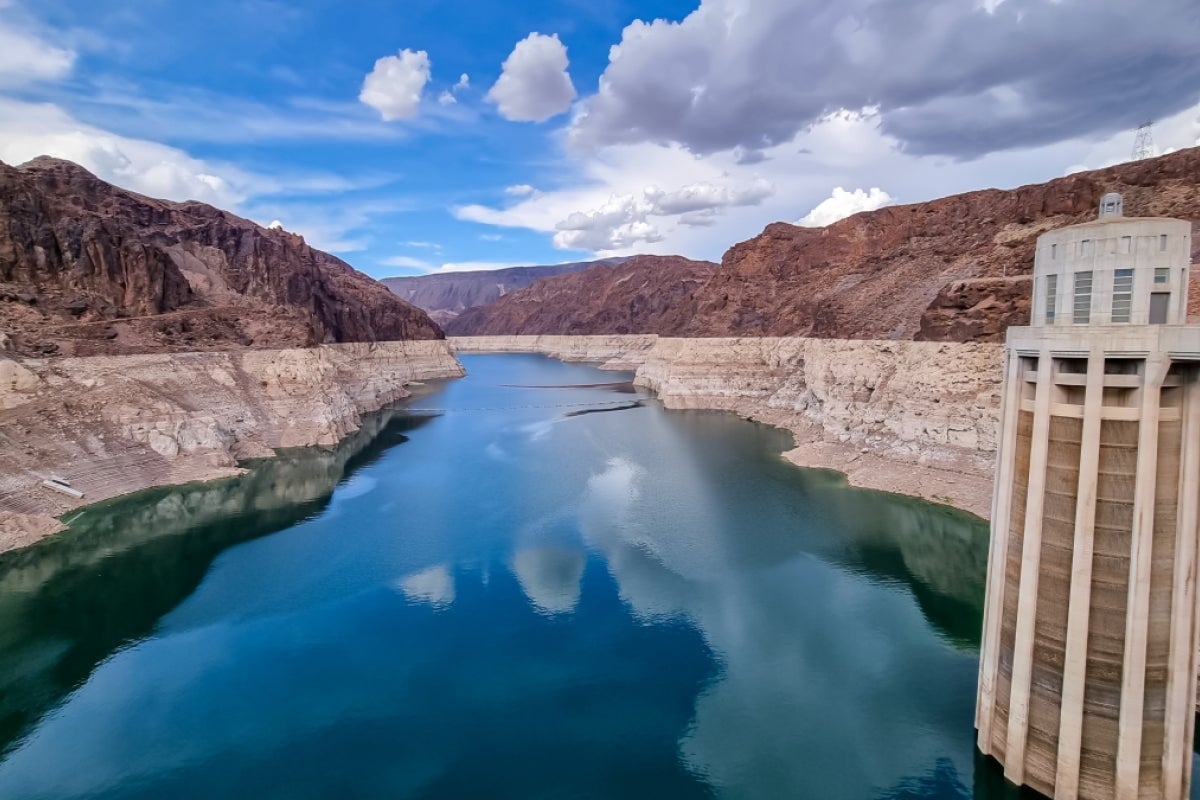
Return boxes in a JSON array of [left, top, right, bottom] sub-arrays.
[[1163, 374, 1200, 800]]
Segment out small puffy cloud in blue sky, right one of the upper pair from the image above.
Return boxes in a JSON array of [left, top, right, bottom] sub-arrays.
[[487, 32, 575, 122]]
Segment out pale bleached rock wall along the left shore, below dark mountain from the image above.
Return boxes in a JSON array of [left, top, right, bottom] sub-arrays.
[[0, 341, 463, 551]]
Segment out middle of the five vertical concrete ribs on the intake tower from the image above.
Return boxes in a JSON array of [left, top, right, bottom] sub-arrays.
[[1055, 347, 1104, 800]]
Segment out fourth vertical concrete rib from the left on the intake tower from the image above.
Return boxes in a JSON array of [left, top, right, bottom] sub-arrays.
[[1116, 353, 1170, 800]]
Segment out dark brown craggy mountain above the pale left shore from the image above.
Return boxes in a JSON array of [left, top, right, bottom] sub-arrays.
[[0, 157, 442, 355]]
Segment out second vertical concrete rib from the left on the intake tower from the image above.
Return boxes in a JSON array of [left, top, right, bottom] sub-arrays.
[[1004, 349, 1054, 783]]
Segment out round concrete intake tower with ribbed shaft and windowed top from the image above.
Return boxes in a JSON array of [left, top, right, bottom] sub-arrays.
[[976, 194, 1200, 800]]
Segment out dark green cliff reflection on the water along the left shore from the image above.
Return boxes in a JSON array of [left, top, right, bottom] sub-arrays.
[[0, 409, 427, 754]]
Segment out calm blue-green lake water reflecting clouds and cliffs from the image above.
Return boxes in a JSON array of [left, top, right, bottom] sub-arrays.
[[0, 355, 1161, 800]]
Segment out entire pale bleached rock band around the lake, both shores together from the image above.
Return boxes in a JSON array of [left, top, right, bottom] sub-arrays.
[[0, 335, 1002, 552]]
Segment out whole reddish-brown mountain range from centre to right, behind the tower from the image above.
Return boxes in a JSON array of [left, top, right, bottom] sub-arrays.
[[449, 149, 1200, 342]]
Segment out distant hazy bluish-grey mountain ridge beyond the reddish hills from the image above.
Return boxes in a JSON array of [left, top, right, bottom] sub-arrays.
[[382, 258, 626, 325]]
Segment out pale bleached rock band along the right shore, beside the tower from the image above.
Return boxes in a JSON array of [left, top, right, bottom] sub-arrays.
[[450, 336, 1003, 517]]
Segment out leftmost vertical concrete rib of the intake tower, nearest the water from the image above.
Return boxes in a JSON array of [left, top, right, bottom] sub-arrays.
[[976, 351, 1025, 756]]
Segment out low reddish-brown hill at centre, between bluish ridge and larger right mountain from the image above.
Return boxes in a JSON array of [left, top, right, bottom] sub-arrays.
[[446, 255, 716, 336]]
